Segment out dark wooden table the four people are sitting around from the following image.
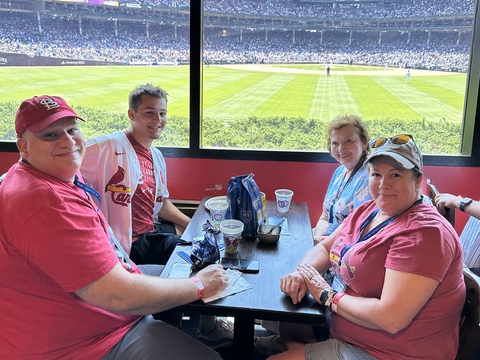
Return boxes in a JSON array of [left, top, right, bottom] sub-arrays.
[[162, 197, 325, 360]]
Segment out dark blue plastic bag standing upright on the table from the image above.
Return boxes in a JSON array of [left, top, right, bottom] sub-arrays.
[[225, 174, 263, 238]]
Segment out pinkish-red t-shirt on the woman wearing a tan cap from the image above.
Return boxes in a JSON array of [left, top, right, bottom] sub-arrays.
[[330, 201, 465, 360]]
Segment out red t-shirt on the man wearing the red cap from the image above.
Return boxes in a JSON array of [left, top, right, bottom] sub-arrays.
[[0, 162, 140, 359]]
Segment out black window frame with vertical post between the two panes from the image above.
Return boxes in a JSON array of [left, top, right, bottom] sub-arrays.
[[0, 0, 480, 167]]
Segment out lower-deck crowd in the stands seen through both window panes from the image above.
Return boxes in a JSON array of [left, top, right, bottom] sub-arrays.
[[0, 5, 471, 71]]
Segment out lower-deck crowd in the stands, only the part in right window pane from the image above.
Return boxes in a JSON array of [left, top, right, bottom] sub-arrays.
[[204, 30, 471, 71]]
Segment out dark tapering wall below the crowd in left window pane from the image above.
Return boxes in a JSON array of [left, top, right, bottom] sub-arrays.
[[0, 51, 124, 66]]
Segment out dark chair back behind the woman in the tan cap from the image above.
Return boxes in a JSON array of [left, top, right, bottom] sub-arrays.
[[456, 267, 480, 360]]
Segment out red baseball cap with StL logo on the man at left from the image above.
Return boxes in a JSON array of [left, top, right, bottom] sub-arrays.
[[15, 95, 85, 137]]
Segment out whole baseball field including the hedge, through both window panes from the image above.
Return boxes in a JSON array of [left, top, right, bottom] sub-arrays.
[[0, 64, 466, 153]]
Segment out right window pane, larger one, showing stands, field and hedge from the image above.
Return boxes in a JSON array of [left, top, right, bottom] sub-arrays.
[[201, 0, 474, 154]]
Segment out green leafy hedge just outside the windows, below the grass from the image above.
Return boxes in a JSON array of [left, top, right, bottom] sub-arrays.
[[0, 101, 462, 155]]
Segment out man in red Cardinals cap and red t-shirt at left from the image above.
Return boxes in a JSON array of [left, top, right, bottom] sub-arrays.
[[0, 95, 228, 360]]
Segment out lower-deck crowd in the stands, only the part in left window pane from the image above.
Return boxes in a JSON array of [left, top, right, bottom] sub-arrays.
[[0, 14, 189, 62]]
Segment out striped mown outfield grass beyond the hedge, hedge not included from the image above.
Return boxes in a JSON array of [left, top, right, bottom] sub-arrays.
[[0, 64, 466, 153]]
